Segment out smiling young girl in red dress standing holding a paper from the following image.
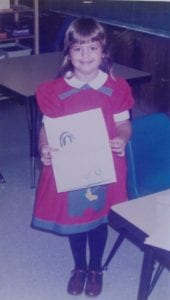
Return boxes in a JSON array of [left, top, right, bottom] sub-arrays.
[[32, 18, 134, 296]]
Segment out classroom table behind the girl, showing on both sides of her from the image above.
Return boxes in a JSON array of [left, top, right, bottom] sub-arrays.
[[0, 52, 151, 187]]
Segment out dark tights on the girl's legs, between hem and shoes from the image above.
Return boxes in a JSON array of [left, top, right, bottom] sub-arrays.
[[69, 224, 107, 271]]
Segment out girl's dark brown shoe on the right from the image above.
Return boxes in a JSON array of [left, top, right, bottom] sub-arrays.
[[85, 271, 103, 297]]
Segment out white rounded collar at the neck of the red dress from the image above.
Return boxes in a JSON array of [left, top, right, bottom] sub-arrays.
[[64, 70, 108, 90]]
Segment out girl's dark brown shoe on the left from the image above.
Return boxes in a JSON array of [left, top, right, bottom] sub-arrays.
[[67, 270, 87, 295]]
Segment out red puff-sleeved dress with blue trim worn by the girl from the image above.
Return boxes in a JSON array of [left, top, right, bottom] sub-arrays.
[[32, 74, 134, 235]]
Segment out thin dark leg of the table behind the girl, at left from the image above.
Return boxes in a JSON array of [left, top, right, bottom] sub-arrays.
[[26, 96, 37, 188]]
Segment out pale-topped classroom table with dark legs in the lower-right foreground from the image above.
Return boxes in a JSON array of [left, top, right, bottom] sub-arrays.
[[103, 189, 170, 300]]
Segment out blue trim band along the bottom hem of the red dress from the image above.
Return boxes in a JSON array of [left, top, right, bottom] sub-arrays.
[[31, 216, 108, 235]]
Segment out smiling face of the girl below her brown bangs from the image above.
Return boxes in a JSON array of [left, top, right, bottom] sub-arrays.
[[69, 41, 103, 82]]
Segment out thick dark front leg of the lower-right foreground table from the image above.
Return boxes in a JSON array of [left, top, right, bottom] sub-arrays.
[[137, 246, 155, 300]]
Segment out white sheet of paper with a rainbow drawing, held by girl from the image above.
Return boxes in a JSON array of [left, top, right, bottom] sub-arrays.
[[44, 108, 116, 192]]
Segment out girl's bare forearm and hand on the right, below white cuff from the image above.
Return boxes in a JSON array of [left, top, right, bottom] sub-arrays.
[[110, 120, 131, 157]]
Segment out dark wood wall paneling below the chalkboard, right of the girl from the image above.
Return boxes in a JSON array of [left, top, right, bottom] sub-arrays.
[[107, 26, 170, 112]]
